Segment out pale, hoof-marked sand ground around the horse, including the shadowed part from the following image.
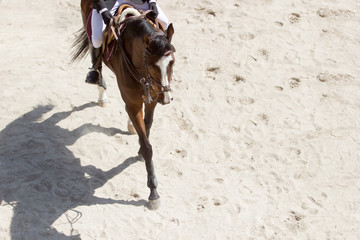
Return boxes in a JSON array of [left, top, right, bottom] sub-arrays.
[[0, 0, 360, 240]]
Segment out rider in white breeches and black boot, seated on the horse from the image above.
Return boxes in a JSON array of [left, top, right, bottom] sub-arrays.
[[85, 0, 169, 87]]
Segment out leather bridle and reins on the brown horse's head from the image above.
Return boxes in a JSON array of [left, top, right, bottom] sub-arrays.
[[116, 15, 174, 104]]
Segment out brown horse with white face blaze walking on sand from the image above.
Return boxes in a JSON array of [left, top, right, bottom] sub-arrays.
[[73, 0, 175, 209]]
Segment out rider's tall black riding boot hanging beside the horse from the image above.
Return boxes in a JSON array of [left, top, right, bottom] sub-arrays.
[[85, 46, 104, 84]]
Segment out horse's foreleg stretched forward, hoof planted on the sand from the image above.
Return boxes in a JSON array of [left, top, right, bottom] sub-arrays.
[[126, 104, 160, 209]]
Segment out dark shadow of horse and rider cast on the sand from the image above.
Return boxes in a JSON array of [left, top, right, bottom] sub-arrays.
[[0, 103, 146, 240]]
